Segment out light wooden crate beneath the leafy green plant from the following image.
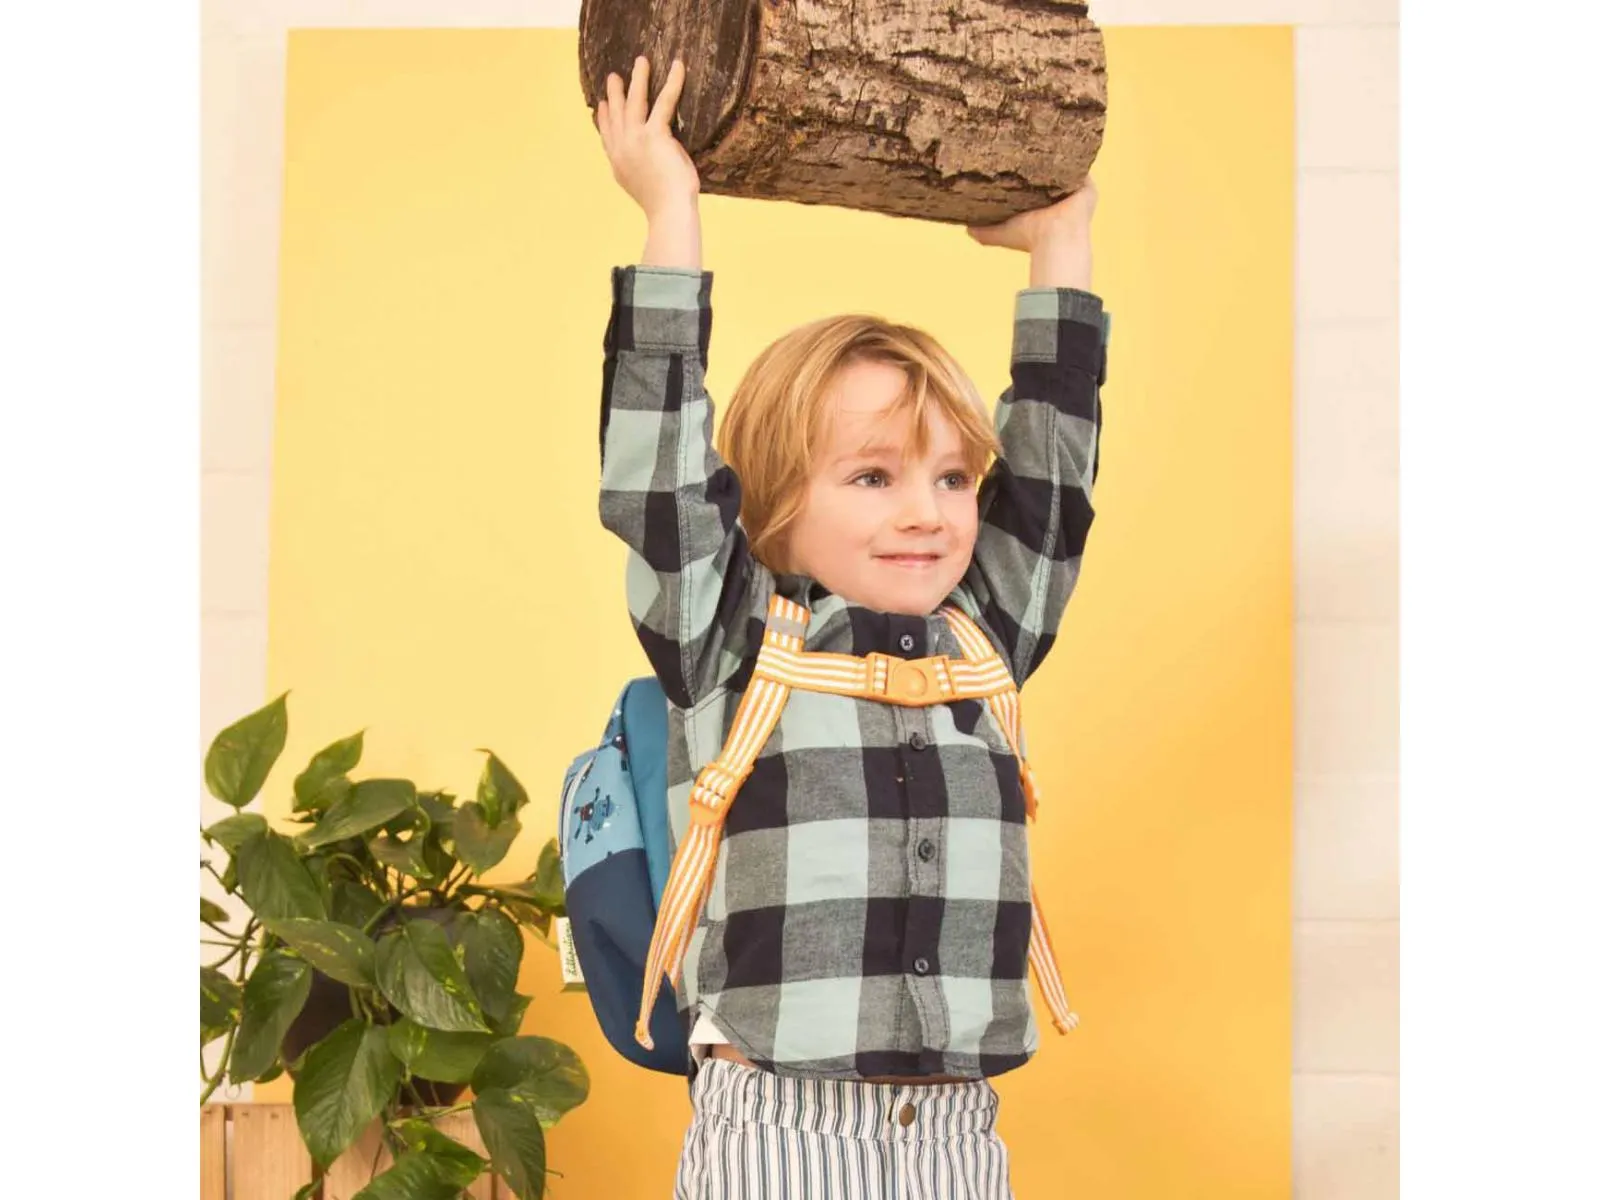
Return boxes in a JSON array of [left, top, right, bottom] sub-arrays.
[[200, 1104, 499, 1200]]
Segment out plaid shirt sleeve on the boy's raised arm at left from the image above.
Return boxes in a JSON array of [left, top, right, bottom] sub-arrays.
[[600, 267, 771, 709]]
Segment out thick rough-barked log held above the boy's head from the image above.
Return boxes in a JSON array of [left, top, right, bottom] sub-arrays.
[[578, 0, 1106, 224]]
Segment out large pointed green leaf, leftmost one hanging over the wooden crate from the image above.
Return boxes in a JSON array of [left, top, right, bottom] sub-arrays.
[[294, 1018, 403, 1166]]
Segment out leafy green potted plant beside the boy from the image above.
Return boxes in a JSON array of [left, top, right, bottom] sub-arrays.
[[200, 693, 589, 1200]]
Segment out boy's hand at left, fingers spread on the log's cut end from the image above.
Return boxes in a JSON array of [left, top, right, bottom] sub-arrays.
[[595, 54, 699, 221]]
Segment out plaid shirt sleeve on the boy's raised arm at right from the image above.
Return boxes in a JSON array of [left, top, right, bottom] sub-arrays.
[[962, 288, 1110, 685]]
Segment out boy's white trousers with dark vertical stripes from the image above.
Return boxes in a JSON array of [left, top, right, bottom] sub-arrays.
[[674, 1059, 1011, 1200]]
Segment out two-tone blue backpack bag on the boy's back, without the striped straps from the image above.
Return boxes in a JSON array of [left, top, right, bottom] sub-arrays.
[[557, 677, 690, 1075]]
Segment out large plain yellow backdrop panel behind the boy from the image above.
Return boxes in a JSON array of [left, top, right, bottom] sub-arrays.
[[258, 27, 1294, 1200]]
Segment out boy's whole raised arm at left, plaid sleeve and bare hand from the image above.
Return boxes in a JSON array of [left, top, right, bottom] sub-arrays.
[[595, 59, 755, 707]]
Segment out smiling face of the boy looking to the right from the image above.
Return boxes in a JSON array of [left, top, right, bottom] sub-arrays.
[[789, 362, 978, 616]]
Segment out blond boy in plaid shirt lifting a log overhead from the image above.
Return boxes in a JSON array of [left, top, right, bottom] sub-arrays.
[[595, 51, 1106, 1200]]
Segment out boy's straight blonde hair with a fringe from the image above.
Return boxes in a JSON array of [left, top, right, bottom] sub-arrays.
[[717, 314, 1000, 571]]
